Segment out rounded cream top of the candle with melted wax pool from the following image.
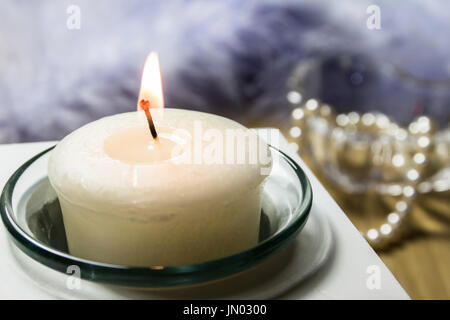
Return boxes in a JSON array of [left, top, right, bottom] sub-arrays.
[[48, 109, 271, 218]]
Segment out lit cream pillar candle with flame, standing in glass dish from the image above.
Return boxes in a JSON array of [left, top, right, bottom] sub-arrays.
[[48, 54, 271, 266]]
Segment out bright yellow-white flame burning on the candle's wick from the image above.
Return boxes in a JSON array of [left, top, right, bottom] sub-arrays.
[[137, 52, 164, 110]]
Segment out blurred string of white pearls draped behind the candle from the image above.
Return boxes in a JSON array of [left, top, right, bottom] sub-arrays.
[[287, 91, 442, 248]]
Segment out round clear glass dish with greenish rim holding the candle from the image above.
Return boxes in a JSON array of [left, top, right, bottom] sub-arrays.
[[0, 146, 312, 288]]
